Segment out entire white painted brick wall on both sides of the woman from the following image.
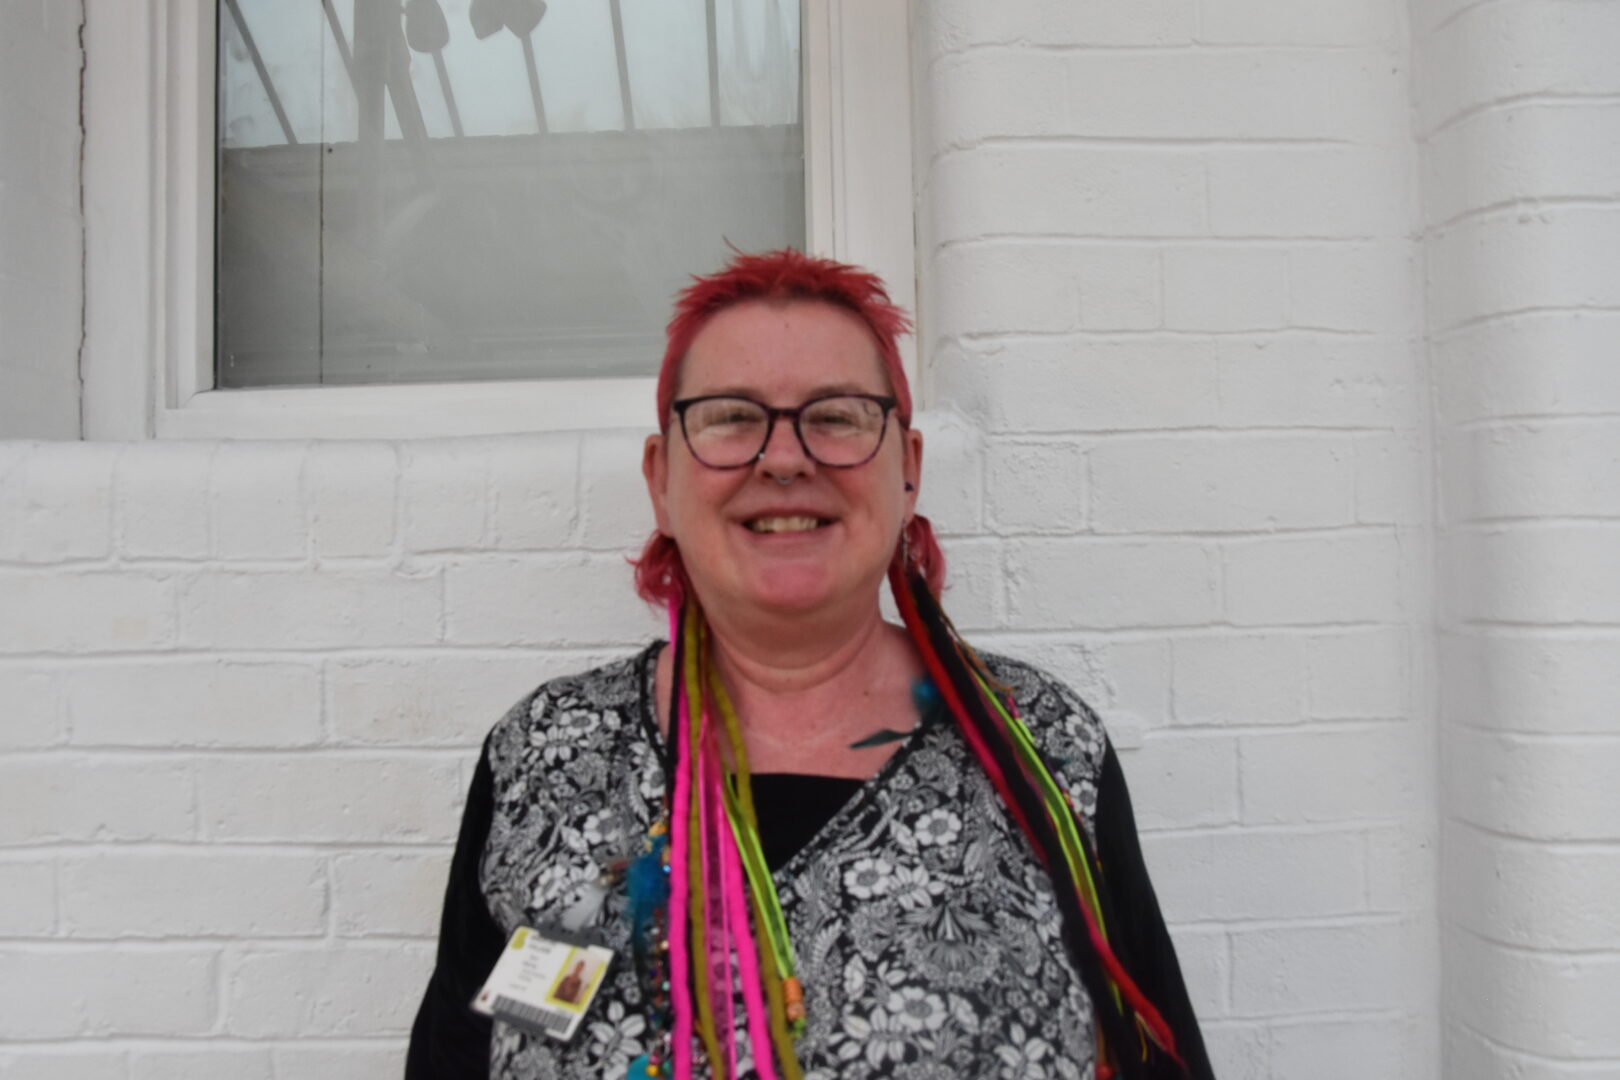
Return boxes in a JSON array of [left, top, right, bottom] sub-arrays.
[[0, 0, 1620, 1080]]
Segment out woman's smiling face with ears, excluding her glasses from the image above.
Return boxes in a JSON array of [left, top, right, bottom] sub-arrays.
[[642, 301, 922, 625]]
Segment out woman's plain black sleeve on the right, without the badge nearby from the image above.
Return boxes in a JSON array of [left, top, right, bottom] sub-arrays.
[[1094, 743, 1215, 1080]]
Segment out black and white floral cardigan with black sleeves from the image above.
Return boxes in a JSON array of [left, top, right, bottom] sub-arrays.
[[407, 644, 1210, 1080]]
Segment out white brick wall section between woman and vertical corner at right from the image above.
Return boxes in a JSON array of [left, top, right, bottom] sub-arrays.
[[914, 0, 1439, 1077]]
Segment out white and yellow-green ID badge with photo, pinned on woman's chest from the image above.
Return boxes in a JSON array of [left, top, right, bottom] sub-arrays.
[[473, 926, 612, 1043]]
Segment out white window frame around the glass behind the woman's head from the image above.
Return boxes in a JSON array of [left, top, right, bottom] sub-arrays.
[[81, 0, 917, 439]]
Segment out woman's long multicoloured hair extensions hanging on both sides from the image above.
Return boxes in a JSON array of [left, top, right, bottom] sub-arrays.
[[669, 563, 1186, 1080]]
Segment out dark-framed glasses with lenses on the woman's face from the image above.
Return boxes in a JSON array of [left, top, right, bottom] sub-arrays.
[[672, 393, 896, 468]]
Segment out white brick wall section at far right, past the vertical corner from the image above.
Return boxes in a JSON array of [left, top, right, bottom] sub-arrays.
[[1413, 0, 1620, 1080]]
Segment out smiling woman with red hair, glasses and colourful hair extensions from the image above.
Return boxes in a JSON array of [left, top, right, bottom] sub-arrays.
[[407, 251, 1210, 1078]]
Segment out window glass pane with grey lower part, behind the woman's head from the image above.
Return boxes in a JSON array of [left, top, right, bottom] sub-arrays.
[[217, 0, 805, 387]]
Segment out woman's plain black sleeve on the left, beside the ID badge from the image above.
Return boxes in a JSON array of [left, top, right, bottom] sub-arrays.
[[405, 740, 505, 1080]]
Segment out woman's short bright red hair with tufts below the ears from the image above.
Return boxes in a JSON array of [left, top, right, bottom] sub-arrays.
[[635, 248, 944, 606]]
